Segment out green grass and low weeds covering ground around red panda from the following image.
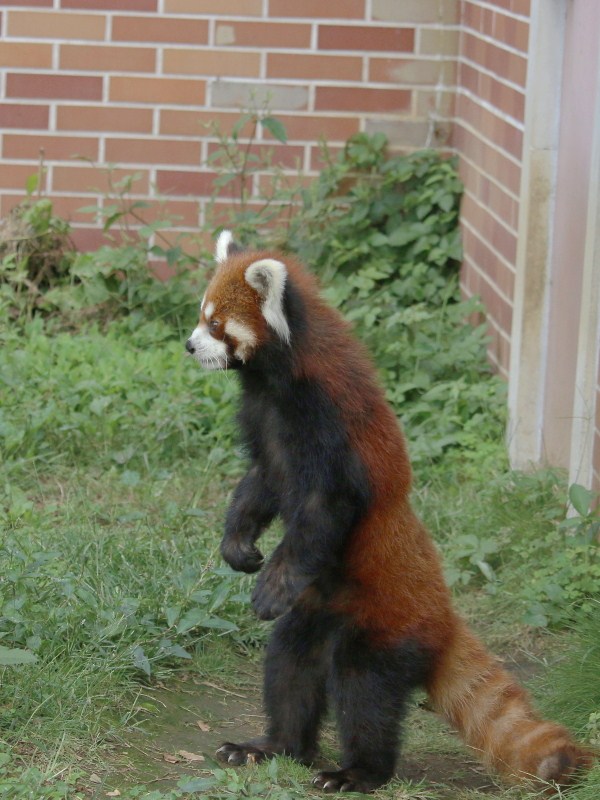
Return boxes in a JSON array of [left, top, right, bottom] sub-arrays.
[[0, 321, 600, 800]]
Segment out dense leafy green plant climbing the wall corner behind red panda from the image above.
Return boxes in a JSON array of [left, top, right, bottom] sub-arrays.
[[287, 134, 504, 462]]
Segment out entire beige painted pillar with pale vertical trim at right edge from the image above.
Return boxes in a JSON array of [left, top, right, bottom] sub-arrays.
[[509, 0, 600, 486]]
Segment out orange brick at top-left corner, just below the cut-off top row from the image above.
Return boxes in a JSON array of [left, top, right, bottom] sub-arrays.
[[7, 11, 106, 41]]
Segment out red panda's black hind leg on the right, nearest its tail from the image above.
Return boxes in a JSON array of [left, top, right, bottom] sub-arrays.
[[314, 629, 427, 792]]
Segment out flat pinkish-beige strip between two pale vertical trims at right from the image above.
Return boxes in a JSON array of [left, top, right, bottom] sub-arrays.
[[542, 0, 600, 466]]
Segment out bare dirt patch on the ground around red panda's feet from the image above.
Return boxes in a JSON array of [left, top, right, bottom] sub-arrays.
[[97, 677, 506, 798]]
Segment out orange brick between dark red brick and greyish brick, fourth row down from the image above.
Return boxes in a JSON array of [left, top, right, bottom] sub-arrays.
[[110, 75, 206, 106]]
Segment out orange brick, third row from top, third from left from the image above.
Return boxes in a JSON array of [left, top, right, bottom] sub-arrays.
[[163, 48, 261, 78]]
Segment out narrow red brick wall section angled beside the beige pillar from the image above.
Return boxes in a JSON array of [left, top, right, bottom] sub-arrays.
[[452, 0, 529, 375]]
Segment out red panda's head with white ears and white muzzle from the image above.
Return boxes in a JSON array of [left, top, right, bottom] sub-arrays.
[[186, 231, 291, 369]]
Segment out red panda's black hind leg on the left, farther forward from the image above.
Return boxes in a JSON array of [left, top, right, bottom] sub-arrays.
[[217, 607, 337, 765]]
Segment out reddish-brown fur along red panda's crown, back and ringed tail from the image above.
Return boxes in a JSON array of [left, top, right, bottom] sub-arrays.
[[207, 247, 592, 783]]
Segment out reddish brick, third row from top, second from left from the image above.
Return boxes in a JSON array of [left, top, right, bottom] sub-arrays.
[[60, 44, 156, 73]]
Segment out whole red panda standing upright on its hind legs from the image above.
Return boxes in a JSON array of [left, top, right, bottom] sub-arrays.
[[186, 231, 592, 792]]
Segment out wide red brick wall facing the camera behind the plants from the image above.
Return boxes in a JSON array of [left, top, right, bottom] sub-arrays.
[[0, 0, 458, 253]]
